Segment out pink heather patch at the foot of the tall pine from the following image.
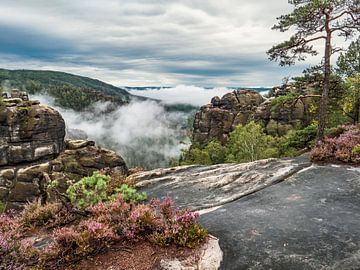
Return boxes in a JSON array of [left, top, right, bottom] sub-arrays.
[[311, 125, 360, 164]]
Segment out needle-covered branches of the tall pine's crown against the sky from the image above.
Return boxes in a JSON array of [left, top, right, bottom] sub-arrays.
[[268, 0, 360, 66]]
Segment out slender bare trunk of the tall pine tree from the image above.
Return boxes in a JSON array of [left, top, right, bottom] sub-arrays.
[[316, 15, 332, 144]]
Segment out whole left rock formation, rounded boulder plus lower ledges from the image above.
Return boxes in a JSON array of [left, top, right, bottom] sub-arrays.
[[0, 96, 127, 209]]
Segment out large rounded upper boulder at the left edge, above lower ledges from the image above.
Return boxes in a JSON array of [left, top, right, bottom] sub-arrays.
[[0, 98, 65, 163]]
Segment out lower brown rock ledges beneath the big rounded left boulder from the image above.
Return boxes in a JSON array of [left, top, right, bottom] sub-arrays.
[[0, 141, 127, 209]]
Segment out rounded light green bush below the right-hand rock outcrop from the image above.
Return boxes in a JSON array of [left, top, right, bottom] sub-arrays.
[[226, 122, 278, 163]]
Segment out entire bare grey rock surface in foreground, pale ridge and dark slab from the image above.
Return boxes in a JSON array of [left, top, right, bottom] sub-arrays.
[[133, 157, 360, 270]]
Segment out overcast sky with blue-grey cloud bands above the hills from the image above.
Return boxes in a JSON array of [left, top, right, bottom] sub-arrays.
[[0, 0, 340, 87]]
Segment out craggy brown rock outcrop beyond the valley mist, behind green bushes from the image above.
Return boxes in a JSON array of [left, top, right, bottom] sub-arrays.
[[193, 87, 311, 145]]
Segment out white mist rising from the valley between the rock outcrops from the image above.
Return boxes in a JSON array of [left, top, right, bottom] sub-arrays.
[[31, 95, 193, 169]]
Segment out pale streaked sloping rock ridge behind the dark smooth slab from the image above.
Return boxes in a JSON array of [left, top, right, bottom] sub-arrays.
[[131, 156, 311, 210]]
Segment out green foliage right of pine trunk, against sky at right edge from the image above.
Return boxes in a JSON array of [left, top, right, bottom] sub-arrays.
[[336, 37, 360, 77]]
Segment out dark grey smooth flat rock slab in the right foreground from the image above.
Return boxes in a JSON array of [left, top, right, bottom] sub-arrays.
[[201, 163, 360, 270]]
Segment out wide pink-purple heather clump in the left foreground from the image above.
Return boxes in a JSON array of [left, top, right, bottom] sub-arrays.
[[0, 194, 207, 269]]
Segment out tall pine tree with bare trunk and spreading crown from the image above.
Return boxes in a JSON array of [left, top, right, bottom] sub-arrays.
[[268, 0, 360, 143]]
